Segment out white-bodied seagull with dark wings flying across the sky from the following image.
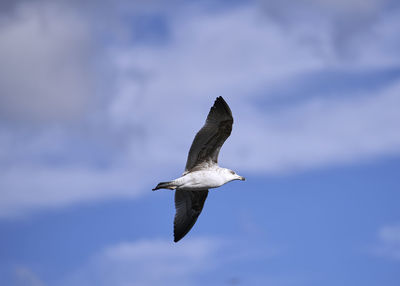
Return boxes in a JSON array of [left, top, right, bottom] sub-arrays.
[[153, 96, 245, 242]]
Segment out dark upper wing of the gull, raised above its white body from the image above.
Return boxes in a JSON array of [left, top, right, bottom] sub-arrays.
[[185, 96, 233, 172]]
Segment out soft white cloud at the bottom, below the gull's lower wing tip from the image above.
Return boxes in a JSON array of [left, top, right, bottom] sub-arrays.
[[61, 237, 280, 286]]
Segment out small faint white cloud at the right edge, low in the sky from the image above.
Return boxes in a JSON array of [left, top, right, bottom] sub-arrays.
[[373, 224, 400, 261]]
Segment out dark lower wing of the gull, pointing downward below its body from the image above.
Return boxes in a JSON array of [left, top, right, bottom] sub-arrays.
[[174, 190, 208, 242]]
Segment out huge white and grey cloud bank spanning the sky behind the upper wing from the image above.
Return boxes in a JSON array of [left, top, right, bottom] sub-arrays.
[[0, 1, 400, 217]]
